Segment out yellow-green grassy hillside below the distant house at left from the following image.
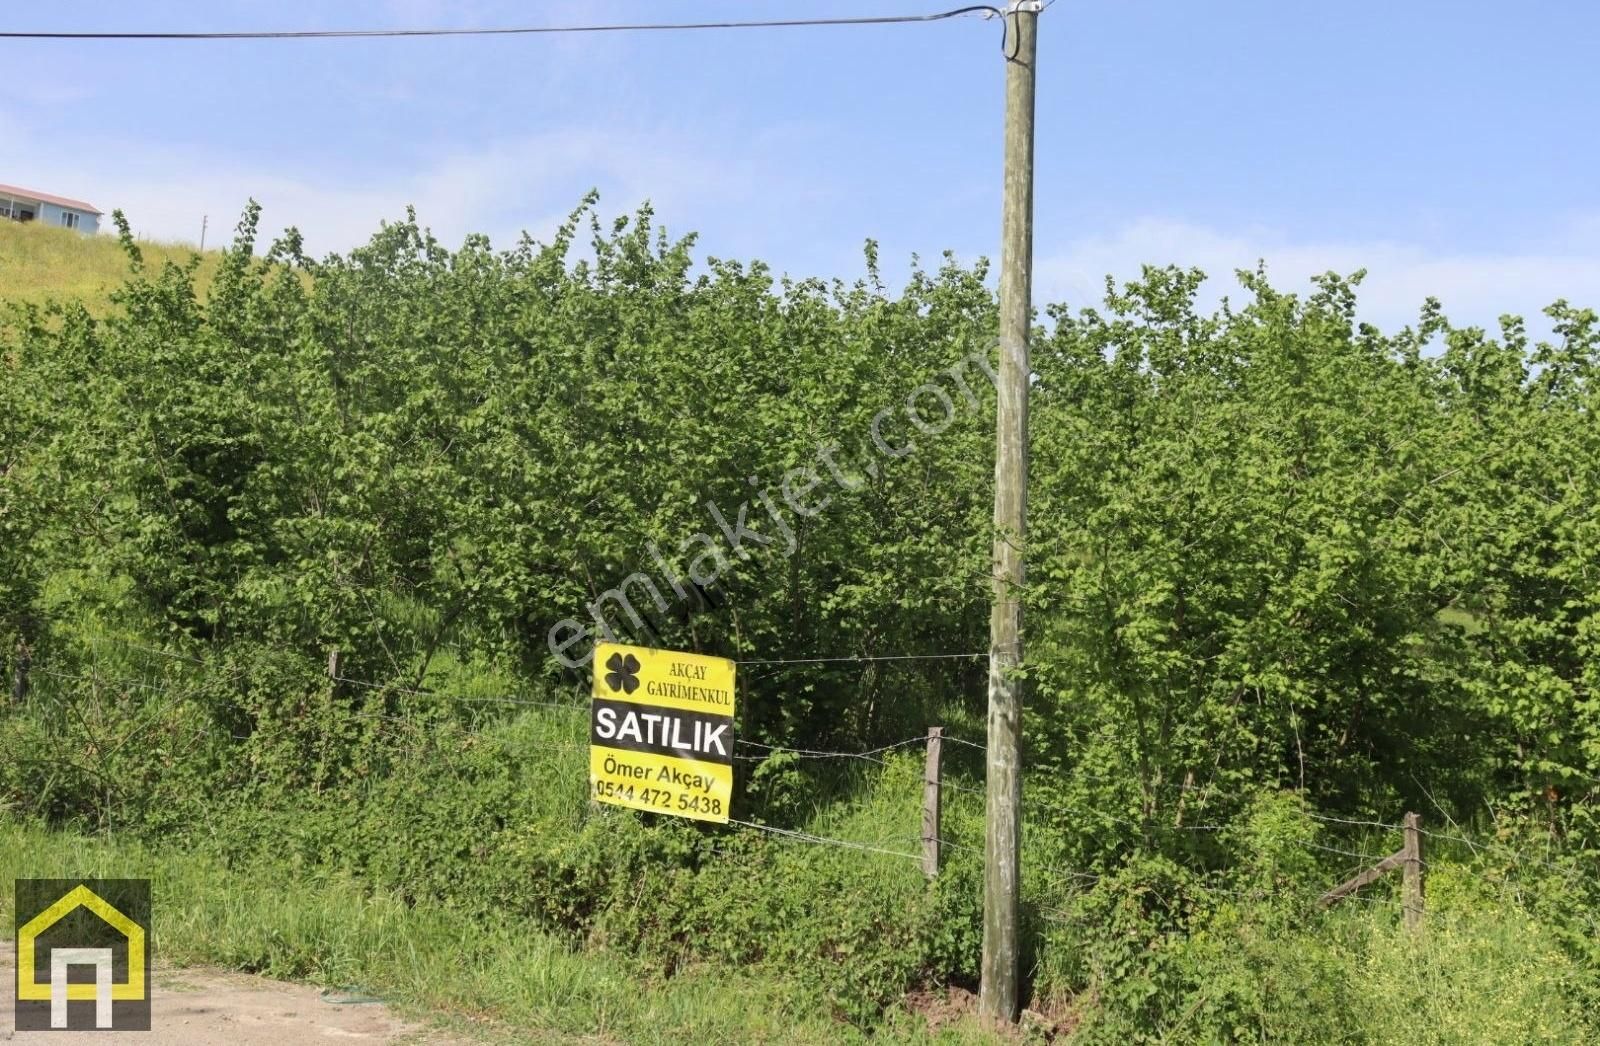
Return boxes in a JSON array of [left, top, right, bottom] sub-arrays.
[[0, 221, 218, 312]]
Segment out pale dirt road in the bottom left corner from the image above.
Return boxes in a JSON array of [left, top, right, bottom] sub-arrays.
[[0, 940, 466, 1046]]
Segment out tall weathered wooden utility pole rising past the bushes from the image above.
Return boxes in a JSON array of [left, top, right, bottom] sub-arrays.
[[978, 0, 1043, 1024]]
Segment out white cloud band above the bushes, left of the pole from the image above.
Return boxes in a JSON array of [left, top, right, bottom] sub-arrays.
[[6, 117, 784, 253]]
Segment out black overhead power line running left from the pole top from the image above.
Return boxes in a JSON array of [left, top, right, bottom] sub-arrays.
[[0, 3, 1005, 40]]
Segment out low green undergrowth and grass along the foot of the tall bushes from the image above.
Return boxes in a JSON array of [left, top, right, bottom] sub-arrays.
[[12, 646, 1600, 1044]]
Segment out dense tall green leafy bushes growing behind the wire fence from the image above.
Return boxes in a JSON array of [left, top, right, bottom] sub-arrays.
[[0, 198, 1600, 1041]]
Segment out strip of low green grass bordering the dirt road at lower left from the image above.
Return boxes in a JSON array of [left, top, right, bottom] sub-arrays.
[[0, 822, 947, 1043]]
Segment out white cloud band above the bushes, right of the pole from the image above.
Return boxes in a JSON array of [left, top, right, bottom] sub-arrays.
[[1035, 218, 1600, 334]]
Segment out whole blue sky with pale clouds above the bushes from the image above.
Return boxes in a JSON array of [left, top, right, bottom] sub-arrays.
[[0, 0, 1600, 334]]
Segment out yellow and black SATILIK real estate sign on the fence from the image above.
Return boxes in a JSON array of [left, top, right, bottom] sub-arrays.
[[589, 643, 734, 824]]
